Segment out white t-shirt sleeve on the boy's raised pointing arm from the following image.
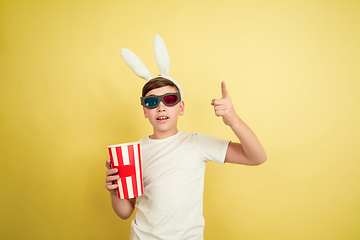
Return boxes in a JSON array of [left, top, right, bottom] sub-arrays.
[[193, 132, 230, 164]]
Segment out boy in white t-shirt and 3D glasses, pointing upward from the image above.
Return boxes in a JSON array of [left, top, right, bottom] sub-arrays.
[[106, 76, 266, 240]]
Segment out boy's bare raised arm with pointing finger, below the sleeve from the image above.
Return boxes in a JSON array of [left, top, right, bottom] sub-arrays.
[[211, 81, 267, 165]]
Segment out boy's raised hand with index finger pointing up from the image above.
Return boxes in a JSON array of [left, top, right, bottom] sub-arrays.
[[211, 81, 239, 126]]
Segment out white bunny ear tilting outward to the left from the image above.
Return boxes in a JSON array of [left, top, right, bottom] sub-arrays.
[[121, 48, 152, 81]]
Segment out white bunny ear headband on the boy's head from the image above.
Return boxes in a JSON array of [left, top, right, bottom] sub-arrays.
[[121, 35, 184, 100]]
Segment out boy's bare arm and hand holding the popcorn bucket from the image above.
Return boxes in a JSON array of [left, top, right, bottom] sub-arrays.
[[106, 159, 136, 220]]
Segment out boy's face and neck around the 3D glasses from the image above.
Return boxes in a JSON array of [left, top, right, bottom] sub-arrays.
[[143, 86, 184, 137]]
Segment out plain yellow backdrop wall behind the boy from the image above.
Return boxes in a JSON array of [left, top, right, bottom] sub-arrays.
[[0, 0, 360, 240]]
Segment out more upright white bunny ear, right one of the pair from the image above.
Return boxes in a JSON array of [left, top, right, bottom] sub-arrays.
[[154, 35, 170, 76]]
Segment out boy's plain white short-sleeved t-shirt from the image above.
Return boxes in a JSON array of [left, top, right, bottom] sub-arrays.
[[130, 131, 229, 240]]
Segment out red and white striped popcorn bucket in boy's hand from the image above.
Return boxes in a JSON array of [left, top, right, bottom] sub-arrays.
[[108, 142, 144, 199]]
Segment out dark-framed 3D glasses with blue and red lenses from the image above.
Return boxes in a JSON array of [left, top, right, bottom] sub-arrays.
[[141, 92, 181, 109]]
